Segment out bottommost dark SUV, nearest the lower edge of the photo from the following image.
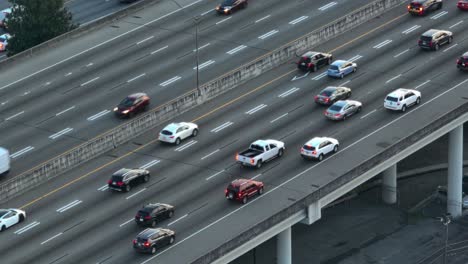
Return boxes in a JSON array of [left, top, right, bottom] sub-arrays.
[[133, 228, 175, 254]]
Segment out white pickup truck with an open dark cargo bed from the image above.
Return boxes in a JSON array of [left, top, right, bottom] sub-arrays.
[[236, 139, 284, 168]]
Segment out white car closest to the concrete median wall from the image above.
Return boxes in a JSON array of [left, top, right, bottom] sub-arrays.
[[159, 122, 198, 145]]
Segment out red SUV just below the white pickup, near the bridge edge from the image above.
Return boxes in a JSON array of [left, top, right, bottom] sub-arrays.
[[224, 179, 263, 204]]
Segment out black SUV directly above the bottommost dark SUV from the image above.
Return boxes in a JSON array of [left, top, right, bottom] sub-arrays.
[[135, 203, 174, 227]]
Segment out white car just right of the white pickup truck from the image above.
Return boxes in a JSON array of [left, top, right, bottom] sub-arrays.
[[301, 137, 340, 161]]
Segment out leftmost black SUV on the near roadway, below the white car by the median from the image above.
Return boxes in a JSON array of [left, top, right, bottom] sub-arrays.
[[107, 168, 150, 192]]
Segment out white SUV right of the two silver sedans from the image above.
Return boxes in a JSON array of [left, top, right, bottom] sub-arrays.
[[384, 88, 421, 112]]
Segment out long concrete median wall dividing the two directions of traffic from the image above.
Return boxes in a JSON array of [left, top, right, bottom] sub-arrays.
[[0, 0, 405, 204]]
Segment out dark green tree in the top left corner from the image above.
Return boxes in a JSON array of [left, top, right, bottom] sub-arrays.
[[6, 0, 77, 55]]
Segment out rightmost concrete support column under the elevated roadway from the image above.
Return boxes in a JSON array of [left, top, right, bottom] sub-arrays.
[[447, 125, 463, 217]]
